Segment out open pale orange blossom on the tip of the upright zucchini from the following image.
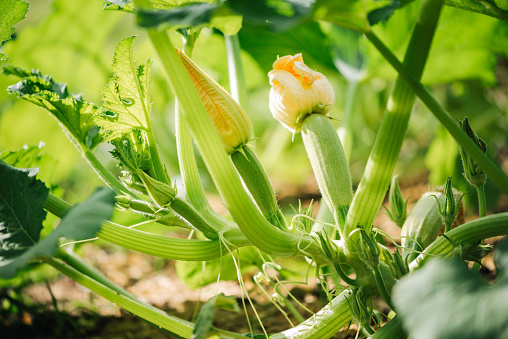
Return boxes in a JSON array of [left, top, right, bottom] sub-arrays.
[[268, 53, 335, 133]]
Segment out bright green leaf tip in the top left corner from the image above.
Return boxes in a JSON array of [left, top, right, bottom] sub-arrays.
[[0, 0, 28, 65]]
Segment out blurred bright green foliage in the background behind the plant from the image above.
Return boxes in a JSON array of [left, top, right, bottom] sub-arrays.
[[0, 0, 508, 216]]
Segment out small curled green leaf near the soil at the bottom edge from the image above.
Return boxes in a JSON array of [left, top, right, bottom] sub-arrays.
[[191, 293, 240, 339]]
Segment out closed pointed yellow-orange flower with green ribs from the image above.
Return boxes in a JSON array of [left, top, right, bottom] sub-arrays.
[[177, 49, 252, 154]]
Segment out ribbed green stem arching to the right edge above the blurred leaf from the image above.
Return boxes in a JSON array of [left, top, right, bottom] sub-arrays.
[[409, 212, 508, 270]]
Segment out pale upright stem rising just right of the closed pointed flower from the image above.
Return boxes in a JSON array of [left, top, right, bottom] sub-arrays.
[[224, 35, 249, 111]]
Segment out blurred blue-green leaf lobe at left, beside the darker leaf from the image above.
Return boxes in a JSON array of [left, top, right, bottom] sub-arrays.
[[0, 188, 115, 279]]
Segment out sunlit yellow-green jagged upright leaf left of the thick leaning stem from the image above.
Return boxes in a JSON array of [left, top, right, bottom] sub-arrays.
[[94, 36, 152, 141]]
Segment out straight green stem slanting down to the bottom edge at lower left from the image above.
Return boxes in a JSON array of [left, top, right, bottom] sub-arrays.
[[46, 258, 194, 338]]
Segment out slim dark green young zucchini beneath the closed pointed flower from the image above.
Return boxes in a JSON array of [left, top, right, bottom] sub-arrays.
[[231, 145, 287, 230]]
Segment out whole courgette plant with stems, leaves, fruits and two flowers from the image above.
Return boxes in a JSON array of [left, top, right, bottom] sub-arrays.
[[0, 0, 508, 338]]
